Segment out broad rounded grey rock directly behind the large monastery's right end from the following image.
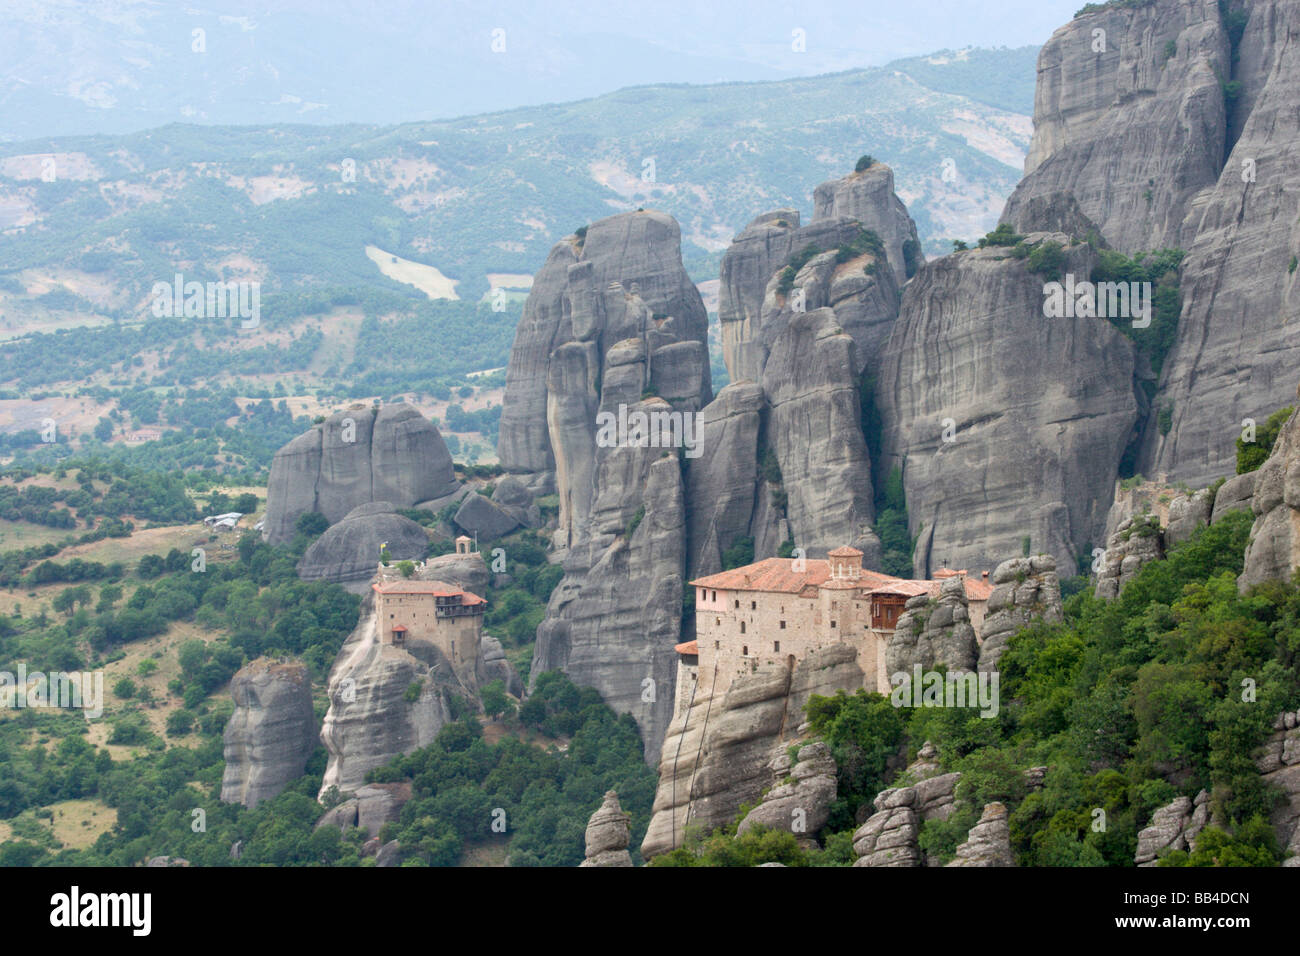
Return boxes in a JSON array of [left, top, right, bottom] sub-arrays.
[[876, 234, 1139, 578]]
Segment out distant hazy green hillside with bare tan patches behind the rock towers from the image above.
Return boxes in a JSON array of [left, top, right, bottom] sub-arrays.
[[0, 44, 1036, 321]]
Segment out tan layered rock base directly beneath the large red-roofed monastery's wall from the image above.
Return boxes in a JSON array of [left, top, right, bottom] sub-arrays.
[[641, 644, 863, 858]]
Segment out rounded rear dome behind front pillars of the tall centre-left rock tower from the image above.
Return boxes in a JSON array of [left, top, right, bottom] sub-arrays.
[[498, 211, 711, 472]]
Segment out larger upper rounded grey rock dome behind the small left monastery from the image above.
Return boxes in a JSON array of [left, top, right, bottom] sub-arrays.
[[263, 403, 458, 544]]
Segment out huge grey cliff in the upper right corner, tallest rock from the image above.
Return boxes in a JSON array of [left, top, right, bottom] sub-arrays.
[[1004, 0, 1300, 485]]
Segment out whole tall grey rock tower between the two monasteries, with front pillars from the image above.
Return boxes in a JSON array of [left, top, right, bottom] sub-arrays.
[[498, 212, 712, 761]]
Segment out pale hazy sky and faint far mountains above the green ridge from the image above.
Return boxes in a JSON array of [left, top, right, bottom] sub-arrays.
[[0, 0, 1084, 140]]
